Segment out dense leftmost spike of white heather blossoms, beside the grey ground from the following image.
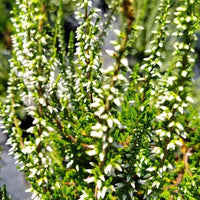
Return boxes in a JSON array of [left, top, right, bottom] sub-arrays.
[[0, 1, 63, 200]]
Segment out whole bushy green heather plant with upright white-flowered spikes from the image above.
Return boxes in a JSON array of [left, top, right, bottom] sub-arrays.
[[1, 0, 200, 200]]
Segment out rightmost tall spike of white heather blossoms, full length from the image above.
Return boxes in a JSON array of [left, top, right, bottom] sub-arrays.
[[143, 1, 197, 199]]
